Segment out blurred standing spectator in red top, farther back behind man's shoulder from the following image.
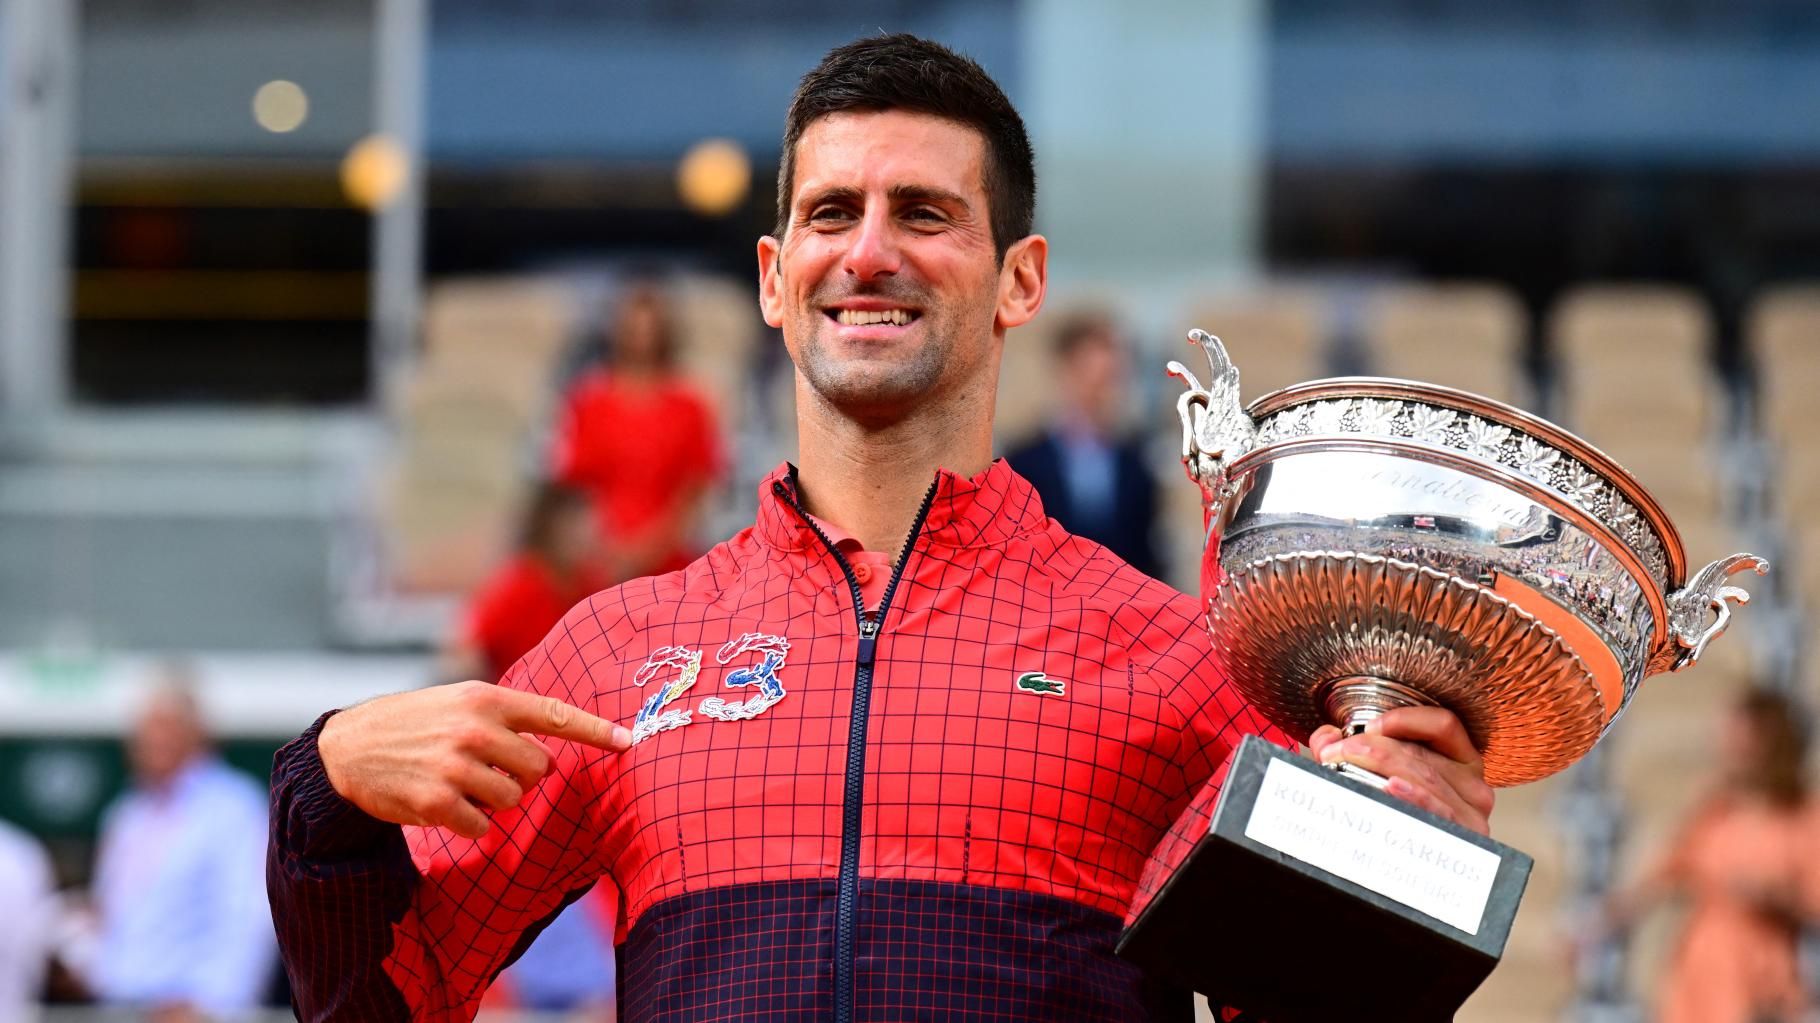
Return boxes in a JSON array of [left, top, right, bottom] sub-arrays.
[[551, 284, 724, 579]]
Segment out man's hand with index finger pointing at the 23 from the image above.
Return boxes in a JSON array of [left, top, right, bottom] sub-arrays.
[[317, 681, 632, 839]]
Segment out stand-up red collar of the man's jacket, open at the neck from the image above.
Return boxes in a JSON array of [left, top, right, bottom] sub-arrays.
[[757, 459, 1048, 555]]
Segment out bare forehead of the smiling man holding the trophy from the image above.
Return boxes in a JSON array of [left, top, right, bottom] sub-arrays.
[[794, 109, 986, 198]]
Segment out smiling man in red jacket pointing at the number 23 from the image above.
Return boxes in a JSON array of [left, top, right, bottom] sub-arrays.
[[269, 36, 1491, 1023]]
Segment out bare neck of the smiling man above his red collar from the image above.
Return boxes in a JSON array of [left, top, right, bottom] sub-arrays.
[[797, 375, 994, 553]]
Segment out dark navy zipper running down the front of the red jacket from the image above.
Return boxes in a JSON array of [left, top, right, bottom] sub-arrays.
[[772, 473, 941, 1023]]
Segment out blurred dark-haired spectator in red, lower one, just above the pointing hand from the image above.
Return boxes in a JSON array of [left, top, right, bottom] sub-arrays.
[[437, 482, 610, 681]]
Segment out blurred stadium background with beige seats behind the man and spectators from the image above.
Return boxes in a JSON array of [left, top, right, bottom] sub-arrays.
[[0, 0, 1820, 1023]]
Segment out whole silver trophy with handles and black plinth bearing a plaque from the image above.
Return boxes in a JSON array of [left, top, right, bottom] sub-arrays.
[[1121, 331, 1767, 1021]]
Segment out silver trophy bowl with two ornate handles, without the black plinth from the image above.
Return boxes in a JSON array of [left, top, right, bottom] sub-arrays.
[[1168, 331, 1767, 786]]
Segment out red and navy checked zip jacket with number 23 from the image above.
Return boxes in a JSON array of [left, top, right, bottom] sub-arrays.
[[269, 462, 1285, 1023]]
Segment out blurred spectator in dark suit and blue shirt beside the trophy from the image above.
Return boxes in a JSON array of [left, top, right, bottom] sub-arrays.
[[1005, 313, 1163, 577]]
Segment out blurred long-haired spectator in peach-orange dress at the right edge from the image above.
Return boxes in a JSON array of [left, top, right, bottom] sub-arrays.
[[1607, 690, 1820, 1023]]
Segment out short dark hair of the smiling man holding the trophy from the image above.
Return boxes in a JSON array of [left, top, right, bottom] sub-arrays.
[[777, 33, 1036, 262]]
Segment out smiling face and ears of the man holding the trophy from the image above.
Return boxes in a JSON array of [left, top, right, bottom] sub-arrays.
[[759, 111, 1045, 422]]
